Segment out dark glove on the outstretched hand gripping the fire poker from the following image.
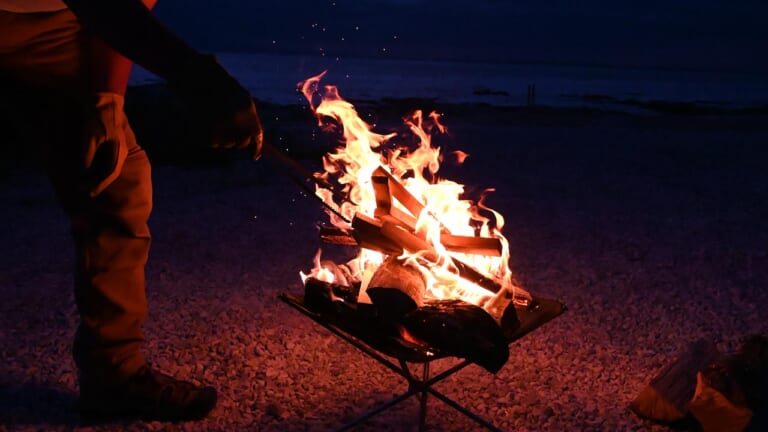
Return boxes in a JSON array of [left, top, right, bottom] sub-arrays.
[[168, 55, 264, 159]]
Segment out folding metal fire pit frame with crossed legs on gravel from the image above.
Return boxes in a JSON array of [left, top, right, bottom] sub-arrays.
[[279, 293, 566, 432]]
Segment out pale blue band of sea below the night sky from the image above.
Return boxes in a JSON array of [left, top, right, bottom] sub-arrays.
[[131, 53, 768, 111]]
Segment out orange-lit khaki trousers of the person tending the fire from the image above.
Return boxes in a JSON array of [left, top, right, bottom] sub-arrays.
[[0, 10, 152, 381]]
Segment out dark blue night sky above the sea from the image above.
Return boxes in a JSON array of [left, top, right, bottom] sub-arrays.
[[156, 0, 768, 73]]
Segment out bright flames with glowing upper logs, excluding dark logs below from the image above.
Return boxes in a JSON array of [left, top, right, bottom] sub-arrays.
[[299, 72, 529, 309]]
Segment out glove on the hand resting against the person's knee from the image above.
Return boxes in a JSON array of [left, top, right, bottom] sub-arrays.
[[81, 93, 133, 197]]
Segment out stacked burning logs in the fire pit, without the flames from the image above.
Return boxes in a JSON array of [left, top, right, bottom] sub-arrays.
[[307, 167, 519, 372]]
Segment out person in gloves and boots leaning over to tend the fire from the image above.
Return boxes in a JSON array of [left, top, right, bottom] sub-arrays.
[[0, 0, 263, 421]]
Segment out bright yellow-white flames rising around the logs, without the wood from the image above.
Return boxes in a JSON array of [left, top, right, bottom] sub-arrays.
[[300, 72, 522, 305]]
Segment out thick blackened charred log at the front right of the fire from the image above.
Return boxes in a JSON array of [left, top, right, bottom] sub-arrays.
[[401, 299, 509, 373]]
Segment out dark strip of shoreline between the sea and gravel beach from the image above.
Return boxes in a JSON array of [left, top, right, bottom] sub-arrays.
[[126, 85, 768, 164]]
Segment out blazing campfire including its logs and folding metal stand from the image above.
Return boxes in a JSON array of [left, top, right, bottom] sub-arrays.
[[280, 72, 565, 431]]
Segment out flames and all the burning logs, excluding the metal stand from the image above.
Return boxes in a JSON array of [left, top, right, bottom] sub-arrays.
[[292, 72, 531, 371]]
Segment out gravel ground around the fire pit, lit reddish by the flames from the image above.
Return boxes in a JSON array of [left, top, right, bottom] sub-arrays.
[[0, 104, 768, 431]]
